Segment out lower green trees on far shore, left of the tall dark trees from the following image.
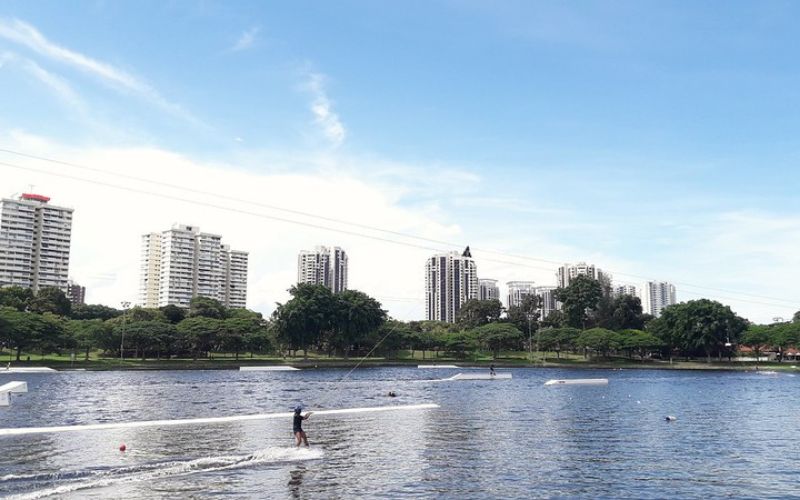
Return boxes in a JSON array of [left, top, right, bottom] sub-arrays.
[[0, 287, 274, 361]]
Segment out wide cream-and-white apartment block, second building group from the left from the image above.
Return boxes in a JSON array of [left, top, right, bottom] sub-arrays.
[[139, 224, 247, 307]]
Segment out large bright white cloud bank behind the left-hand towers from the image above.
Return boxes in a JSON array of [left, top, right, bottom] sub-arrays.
[[0, 132, 459, 319]]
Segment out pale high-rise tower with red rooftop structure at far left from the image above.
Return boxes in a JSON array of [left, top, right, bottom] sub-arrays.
[[0, 194, 72, 292]]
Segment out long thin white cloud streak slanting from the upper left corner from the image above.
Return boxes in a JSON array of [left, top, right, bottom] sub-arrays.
[[0, 19, 201, 125]]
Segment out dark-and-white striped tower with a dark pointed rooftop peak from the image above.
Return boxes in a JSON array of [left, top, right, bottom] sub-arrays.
[[425, 247, 478, 323]]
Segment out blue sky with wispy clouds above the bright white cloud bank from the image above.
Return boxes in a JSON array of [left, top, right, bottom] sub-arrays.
[[0, 1, 800, 320]]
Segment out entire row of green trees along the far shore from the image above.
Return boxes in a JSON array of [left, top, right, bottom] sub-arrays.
[[0, 276, 800, 361]]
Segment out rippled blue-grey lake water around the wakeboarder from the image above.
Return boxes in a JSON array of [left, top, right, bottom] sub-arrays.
[[0, 368, 800, 499]]
